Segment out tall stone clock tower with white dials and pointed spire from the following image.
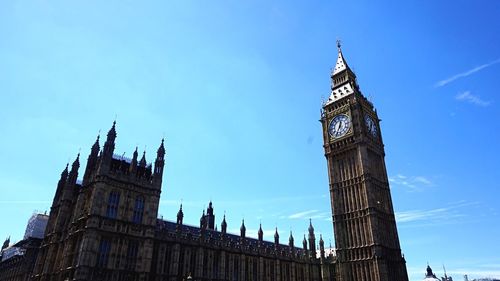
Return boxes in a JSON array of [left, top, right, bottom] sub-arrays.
[[321, 43, 408, 281]]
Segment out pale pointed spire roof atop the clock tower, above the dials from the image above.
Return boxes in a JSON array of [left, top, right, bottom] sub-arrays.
[[325, 40, 359, 105]]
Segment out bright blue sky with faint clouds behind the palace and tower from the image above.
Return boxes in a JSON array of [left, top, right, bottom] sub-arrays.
[[0, 0, 500, 280]]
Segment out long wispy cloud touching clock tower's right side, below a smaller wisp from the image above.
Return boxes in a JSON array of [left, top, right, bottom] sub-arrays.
[[396, 201, 478, 223]]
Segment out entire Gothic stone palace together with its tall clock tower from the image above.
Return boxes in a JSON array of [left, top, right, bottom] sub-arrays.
[[0, 45, 408, 281]]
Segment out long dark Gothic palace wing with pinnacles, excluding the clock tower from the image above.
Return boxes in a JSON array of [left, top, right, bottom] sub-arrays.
[[32, 121, 335, 281]]
